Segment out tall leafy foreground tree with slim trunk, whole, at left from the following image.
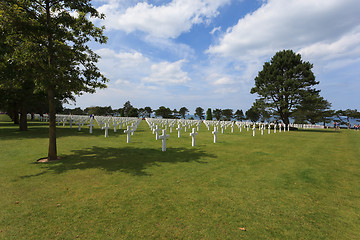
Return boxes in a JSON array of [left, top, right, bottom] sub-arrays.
[[2, 0, 107, 160]]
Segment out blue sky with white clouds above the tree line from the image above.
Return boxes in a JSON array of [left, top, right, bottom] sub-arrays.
[[67, 0, 360, 113]]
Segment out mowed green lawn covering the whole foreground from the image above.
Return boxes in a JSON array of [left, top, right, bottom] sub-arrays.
[[0, 116, 360, 239]]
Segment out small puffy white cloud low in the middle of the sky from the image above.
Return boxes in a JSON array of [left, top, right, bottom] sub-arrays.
[[142, 60, 190, 85]]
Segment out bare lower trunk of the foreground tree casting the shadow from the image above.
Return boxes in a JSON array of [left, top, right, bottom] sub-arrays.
[[48, 86, 57, 160]]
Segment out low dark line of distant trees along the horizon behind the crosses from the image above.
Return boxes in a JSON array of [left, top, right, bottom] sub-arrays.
[[59, 101, 360, 124]]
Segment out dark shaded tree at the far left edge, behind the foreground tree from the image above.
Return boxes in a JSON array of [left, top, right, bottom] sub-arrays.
[[0, 1, 36, 131]]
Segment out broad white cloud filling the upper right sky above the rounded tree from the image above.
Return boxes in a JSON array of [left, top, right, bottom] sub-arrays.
[[208, 0, 360, 60]]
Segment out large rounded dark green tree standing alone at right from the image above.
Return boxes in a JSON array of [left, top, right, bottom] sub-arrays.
[[251, 50, 319, 124]]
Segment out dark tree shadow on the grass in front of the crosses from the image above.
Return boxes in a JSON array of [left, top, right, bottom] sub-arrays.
[[28, 147, 216, 178]]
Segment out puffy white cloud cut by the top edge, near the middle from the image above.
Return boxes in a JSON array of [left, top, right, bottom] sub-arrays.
[[98, 0, 230, 38]]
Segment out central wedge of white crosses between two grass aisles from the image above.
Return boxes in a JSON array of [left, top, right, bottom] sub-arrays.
[[145, 118, 202, 151]]
